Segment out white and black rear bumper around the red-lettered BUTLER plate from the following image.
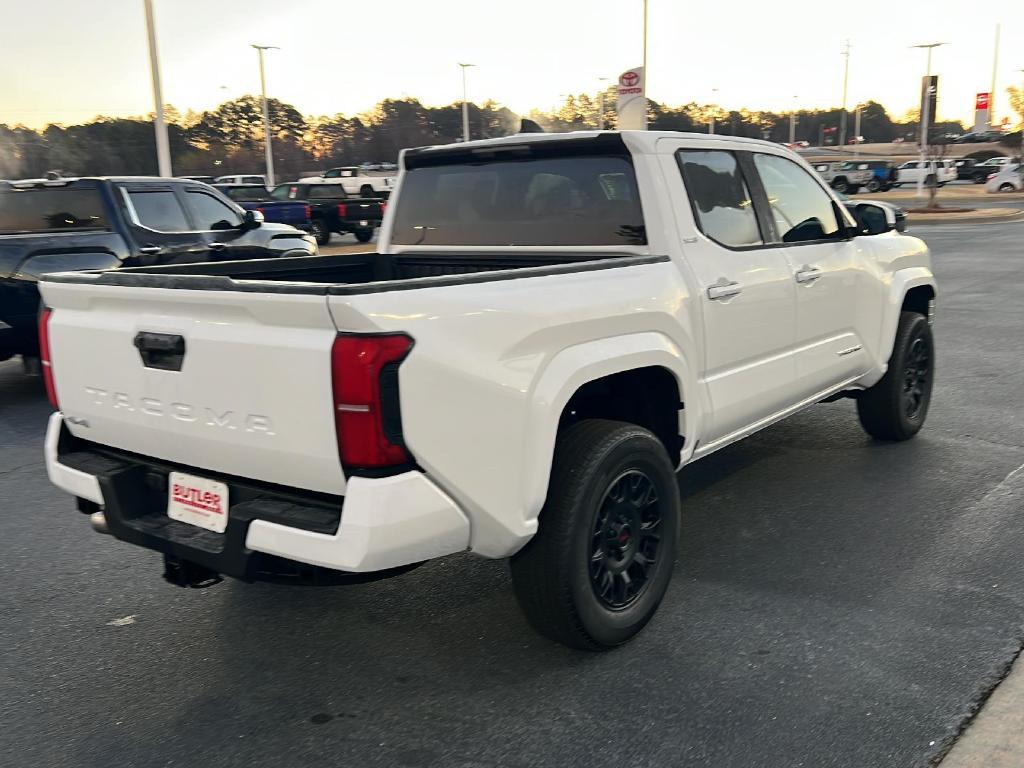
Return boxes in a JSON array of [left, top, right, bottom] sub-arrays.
[[45, 413, 469, 581]]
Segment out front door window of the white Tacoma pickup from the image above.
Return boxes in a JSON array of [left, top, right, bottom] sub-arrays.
[[754, 154, 842, 243]]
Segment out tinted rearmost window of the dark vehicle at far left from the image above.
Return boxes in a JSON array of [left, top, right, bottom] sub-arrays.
[[0, 187, 108, 234]]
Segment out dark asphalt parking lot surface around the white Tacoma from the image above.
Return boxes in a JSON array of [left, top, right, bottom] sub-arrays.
[[0, 222, 1024, 768]]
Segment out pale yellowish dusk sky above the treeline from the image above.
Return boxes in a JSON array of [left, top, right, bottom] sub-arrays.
[[0, 0, 1024, 127]]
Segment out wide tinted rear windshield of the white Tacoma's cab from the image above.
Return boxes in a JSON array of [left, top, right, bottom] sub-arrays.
[[391, 155, 647, 247]]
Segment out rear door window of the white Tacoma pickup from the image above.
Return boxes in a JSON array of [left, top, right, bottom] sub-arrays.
[[677, 150, 764, 248]]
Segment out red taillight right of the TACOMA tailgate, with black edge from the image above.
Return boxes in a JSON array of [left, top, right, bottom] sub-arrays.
[[331, 334, 413, 469]]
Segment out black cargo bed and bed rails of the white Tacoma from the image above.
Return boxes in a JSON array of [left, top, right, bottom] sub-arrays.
[[37, 252, 669, 296]]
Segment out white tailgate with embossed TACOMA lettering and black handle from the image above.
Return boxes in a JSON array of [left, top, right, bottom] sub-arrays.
[[41, 282, 345, 494]]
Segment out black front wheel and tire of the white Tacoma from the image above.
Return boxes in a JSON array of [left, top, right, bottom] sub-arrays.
[[857, 311, 935, 440]]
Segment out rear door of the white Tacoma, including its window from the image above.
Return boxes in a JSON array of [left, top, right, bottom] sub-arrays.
[[662, 140, 796, 447]]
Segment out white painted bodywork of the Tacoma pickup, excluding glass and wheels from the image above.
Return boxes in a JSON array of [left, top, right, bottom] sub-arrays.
[[42, 132, 934, 569]]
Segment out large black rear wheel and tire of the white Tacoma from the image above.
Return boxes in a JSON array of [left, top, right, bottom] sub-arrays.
[[511, 419, 679, 650]]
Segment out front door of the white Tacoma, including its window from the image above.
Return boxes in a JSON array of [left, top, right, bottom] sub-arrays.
[[753, 153, 883, 399]]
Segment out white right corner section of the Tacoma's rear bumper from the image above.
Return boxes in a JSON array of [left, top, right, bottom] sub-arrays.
[[246, 472, 469, 572]]
